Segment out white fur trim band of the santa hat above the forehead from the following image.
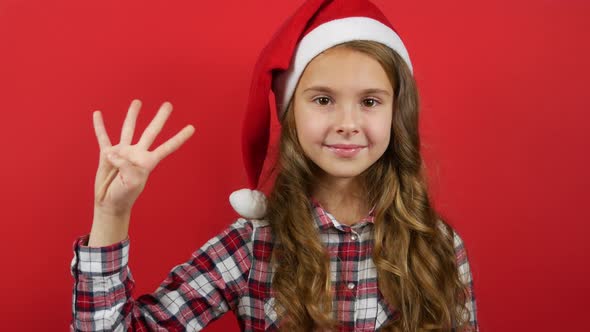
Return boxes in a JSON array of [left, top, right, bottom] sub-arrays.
[[273, 17, 412, 118]]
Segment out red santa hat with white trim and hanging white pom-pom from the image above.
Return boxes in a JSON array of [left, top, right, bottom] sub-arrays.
[[230, 0, 412, 219]]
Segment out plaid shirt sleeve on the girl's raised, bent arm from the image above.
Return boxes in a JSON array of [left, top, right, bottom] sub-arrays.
[[70, 219, 252, 331]]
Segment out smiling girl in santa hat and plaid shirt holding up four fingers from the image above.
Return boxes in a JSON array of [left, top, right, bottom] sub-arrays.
[[71, 0, 478, 331]]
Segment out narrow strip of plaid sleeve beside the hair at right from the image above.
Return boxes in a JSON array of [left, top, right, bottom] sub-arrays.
[[453, 231, 479, 332]]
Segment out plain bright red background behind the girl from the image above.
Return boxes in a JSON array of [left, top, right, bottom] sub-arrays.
[[0, 0, 590, 331]]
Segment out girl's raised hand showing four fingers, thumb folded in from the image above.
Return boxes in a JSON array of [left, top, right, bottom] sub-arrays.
[[93, 100, 194, 214]]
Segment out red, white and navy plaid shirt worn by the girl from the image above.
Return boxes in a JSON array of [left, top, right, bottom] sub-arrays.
[[70, 200, 479, 331]]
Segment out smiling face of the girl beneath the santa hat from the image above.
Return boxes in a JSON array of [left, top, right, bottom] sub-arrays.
[[293, 47, 393, 182]]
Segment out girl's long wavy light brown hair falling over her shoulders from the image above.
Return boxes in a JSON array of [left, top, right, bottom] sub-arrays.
[[266, 41, 469, 331]]
